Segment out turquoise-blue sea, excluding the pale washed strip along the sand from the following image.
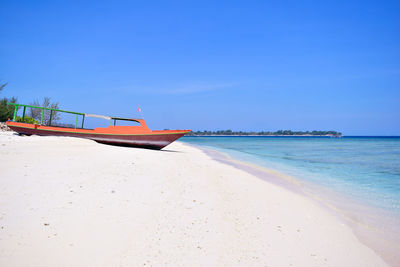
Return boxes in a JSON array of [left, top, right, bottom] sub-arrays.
[[181, 137, 400, 218]]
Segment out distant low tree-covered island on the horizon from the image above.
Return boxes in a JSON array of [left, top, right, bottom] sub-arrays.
[[187, 130, 342, 137]]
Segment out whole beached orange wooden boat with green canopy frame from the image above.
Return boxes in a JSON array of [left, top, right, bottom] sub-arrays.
[[6, 103, 191, 149]]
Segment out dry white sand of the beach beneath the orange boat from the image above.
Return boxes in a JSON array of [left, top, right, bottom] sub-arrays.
[[0, 133, 386, 267]]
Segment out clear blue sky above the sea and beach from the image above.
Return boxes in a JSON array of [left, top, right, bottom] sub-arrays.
[[0, 0, 400, 135]]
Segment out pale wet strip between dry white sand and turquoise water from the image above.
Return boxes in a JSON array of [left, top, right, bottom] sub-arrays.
[[185, 142, 400, 266]]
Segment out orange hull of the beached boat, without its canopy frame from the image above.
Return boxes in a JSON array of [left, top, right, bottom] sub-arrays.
[[6, 120, 190, 149]]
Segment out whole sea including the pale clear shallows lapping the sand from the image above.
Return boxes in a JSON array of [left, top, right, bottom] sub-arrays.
[[181, 137, 400, 264]]
